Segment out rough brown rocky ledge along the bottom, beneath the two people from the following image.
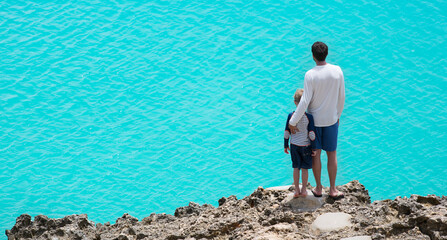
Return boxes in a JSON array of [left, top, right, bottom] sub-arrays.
[[6, 181, 447, 240]]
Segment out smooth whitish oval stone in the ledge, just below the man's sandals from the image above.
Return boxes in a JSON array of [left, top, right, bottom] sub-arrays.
[[312, 212, 352, 232]]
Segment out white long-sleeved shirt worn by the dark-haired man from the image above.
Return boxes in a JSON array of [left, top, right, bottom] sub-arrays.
[[289, 63, 345, 127]]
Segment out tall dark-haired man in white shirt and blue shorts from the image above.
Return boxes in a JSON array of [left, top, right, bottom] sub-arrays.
[[289, 42, 345, 199]]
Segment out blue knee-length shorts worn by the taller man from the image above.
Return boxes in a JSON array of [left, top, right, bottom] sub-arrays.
[[315, 121, 338, 152]]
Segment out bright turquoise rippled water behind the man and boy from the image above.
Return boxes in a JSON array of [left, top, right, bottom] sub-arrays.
[[0, 1, 447, 236]]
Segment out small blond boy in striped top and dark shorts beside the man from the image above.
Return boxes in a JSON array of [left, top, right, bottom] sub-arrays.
[[284, 89, 316, 198]]
